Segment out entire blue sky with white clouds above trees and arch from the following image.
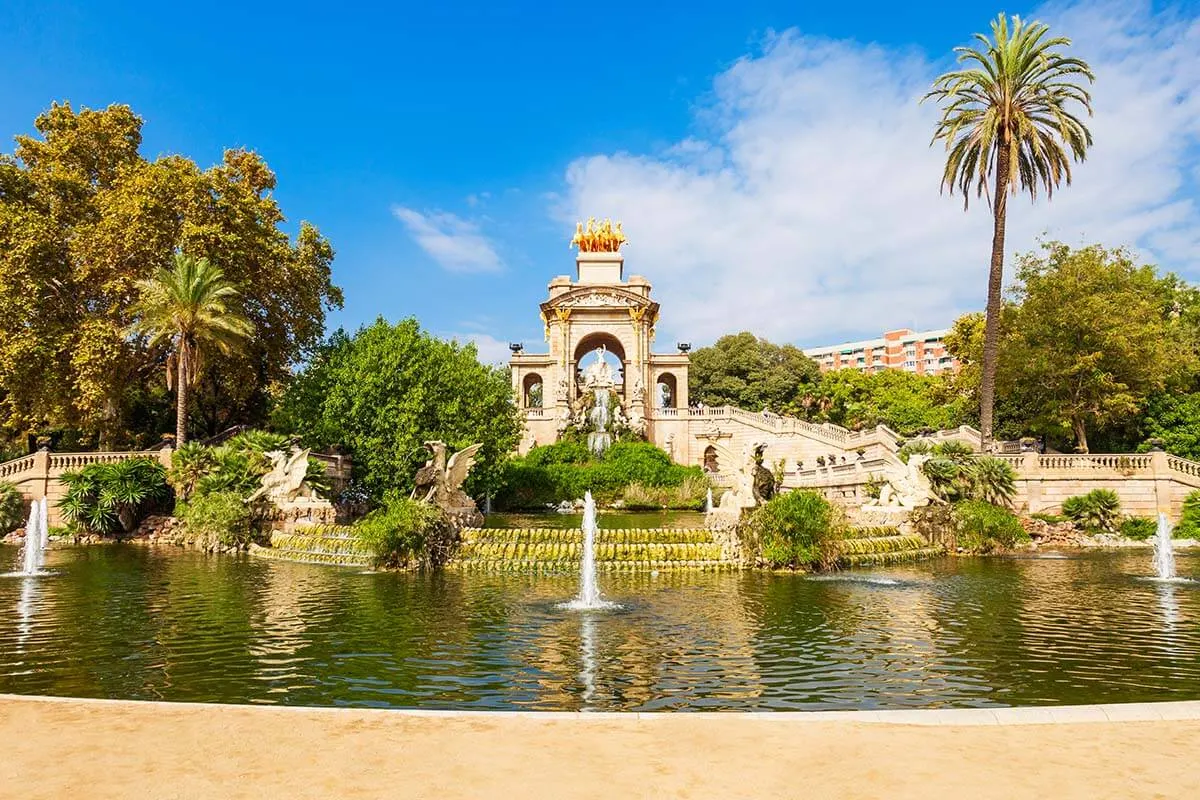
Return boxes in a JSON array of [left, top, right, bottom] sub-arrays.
[[0, 0, 1200, 357]]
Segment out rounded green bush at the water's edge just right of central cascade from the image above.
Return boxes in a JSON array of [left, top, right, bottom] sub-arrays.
[[743, 491, 847, 569]]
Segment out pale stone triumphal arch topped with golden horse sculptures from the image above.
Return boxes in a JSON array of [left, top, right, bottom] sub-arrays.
[[510, 219, 688, 459]]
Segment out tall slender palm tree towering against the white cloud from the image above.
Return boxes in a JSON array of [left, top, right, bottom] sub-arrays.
[[922, 14, 1096, 450]]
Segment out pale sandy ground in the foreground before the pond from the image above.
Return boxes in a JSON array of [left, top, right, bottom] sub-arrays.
[[0, 697, 1200, 800]]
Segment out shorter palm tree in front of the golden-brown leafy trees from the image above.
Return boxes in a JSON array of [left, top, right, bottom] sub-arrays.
[[130, 253, 254, 446]]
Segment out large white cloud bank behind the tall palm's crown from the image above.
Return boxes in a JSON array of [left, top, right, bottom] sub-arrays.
[[558, 2, 1200, 344]]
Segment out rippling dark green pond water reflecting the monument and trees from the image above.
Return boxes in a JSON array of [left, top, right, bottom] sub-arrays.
[[0, 546, 1200, 711]]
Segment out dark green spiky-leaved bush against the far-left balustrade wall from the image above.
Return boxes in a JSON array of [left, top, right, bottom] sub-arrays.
[[59, 458, 170, 535]]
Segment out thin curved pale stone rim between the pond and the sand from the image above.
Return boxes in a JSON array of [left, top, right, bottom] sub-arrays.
[[0, 694, 1200, 727]]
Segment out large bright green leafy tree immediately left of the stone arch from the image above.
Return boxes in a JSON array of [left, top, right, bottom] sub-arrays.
[[274, 319, 521, 500]]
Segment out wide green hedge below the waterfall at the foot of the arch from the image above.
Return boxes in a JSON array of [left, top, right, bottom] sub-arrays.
[[496, 441, 708, 509]]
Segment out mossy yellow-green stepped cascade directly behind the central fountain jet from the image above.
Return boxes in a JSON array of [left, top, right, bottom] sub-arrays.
[[449, 528, 738, 573]]
